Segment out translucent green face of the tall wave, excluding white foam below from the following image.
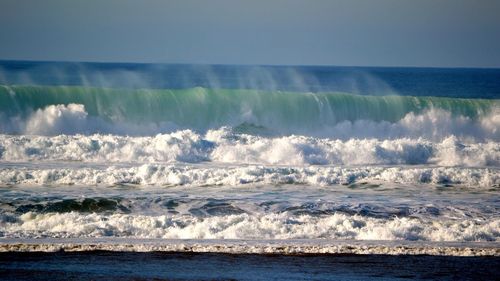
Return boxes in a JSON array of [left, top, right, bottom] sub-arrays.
[[0, 86, 498, 130]]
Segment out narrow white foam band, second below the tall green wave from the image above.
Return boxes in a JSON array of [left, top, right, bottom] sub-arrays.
[[0, 163, 500, 189]]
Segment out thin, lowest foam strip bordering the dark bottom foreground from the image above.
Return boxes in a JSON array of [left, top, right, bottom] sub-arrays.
[[0, 238, 500, 257]]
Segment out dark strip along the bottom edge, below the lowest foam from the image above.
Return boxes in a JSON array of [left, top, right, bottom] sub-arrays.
[[0, 252, 500, 280]]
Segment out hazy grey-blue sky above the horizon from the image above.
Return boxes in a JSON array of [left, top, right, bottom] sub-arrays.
[[0, 0, 500, 67]]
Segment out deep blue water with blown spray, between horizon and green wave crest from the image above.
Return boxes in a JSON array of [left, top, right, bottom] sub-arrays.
[[0, 61, 500, 98]]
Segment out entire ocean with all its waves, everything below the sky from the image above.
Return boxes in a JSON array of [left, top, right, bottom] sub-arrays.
[[0, 61, 500, 280]]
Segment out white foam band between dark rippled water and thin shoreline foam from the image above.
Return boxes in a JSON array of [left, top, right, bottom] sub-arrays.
[[0, 212, 500, 242]]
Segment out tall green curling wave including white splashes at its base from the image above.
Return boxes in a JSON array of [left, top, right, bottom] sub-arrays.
[[0, 86, 500, 140]]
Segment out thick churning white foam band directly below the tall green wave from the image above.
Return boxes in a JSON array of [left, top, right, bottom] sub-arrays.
[[0, 128, 500, 166]]
